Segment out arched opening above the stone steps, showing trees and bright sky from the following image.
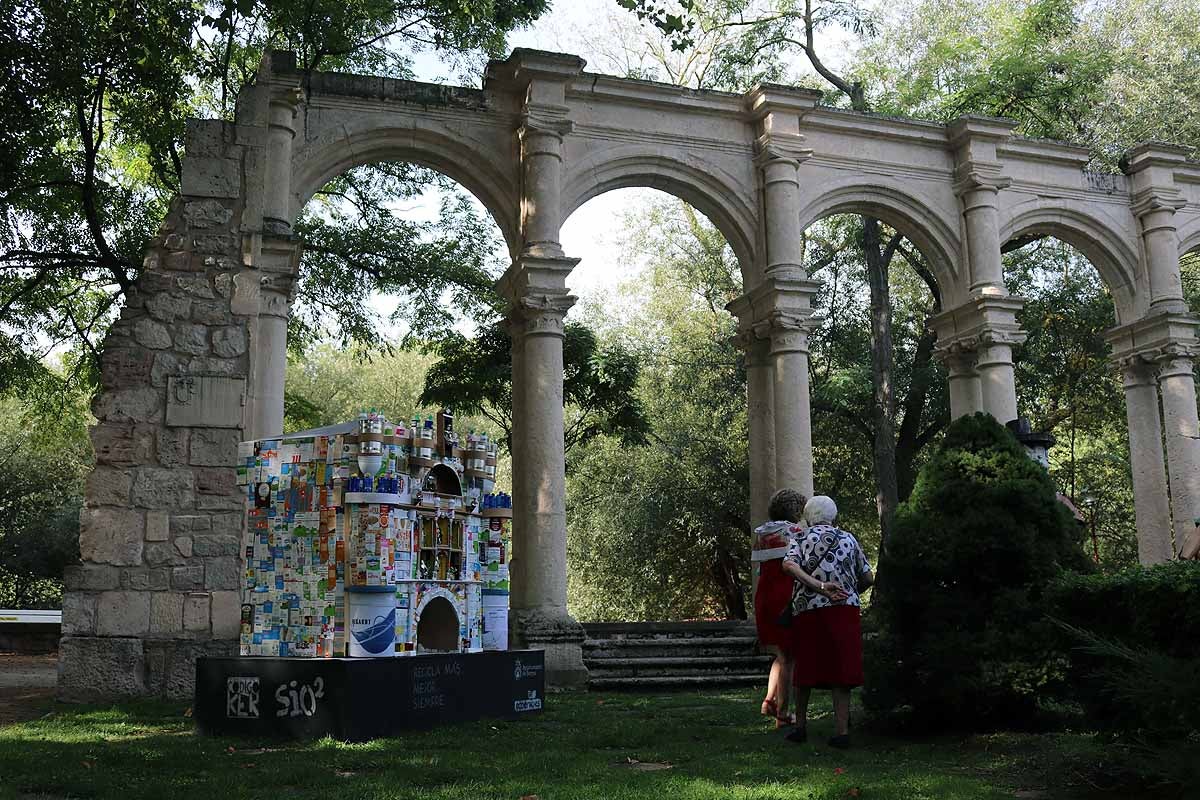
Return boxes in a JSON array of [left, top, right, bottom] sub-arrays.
[[560, 184, 750, 621]]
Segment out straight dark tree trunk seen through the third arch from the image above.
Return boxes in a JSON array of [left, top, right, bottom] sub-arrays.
[[863, 217, 899, 547]]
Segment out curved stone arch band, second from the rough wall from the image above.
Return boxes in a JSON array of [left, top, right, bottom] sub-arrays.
[[562, 148, 755, 281]]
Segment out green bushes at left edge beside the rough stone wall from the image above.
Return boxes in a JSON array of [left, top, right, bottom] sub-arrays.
[[0, 395, 92, 608]]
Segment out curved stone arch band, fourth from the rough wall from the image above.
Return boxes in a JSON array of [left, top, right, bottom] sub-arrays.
[[1000, 206, 1145, 323]]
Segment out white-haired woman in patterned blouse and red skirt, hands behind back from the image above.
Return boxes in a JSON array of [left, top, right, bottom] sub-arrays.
[[784, 495, 875, 748]]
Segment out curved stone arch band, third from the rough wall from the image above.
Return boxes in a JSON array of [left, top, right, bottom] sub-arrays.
[[800, 173, 967, 301]]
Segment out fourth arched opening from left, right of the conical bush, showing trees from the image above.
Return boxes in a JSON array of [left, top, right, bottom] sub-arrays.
[[1003, 232, 1138, 567]]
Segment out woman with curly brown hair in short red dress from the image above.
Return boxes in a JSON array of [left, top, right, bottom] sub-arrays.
[[750, 489, 804, 727]]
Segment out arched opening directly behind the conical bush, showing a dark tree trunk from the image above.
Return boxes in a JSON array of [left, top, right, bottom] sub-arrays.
[[802, 203, 966, 553]]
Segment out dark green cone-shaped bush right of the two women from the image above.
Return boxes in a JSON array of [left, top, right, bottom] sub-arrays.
[[864, 414, 1088, 728]]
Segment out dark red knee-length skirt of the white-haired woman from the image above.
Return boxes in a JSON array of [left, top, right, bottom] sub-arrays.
[[791, 606, 863, 688]]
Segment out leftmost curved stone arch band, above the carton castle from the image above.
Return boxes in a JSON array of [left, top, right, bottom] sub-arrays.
[[290, 122, 521, 257]]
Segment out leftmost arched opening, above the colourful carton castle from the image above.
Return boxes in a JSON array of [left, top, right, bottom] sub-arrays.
[[283, 155, 509, 448]]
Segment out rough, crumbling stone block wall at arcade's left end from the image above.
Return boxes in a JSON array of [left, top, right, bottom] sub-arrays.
[[59, 115, 260, 699]]
